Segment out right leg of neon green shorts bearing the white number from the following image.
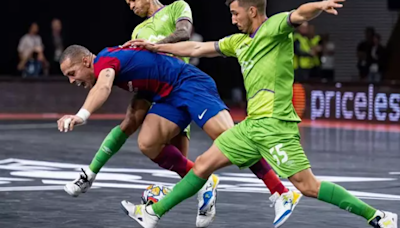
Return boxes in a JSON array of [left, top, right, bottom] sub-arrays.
[[253, 118, 310, 178]]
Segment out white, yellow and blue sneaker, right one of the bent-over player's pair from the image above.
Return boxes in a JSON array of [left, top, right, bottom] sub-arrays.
[[269, 191, 303, 228]]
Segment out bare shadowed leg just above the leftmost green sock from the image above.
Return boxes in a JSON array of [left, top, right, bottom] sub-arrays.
[[120, 99, 150, 136]]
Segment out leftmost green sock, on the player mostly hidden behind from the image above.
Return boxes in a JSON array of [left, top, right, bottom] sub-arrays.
[[89, 126, 128, 173]]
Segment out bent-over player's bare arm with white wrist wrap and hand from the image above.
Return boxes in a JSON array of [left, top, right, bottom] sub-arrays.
[[57, 68, 115, 132]]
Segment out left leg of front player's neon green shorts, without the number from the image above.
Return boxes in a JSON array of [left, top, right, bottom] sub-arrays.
[[214, 120, 261, 169]]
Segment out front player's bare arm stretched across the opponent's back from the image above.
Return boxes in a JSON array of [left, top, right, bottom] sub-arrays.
[[128, 40, 221, 58]]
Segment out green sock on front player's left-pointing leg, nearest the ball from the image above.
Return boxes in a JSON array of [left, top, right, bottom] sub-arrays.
[[153, 170, 207, 217]]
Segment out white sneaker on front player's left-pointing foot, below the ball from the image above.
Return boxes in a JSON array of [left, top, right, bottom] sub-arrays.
[[121, 200, 160, 228]]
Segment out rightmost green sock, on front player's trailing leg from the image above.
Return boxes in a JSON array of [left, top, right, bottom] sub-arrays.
[[318, 181, 376, 220]]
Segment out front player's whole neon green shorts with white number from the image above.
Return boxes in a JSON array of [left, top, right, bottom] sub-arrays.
[[214, 118, 311, 178]]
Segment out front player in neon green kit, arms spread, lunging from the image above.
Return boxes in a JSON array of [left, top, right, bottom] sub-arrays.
[[121, 0, 397, 228]]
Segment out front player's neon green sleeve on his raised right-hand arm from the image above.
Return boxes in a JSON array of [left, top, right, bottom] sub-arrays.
[[268, 11, 297, 35]]
